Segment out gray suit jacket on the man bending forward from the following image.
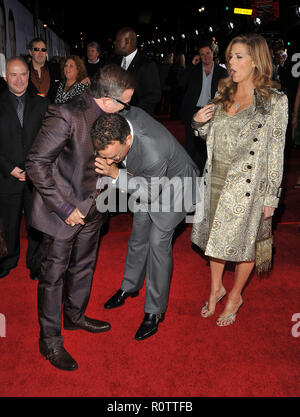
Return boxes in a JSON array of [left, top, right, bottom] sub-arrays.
[[98, 106, 199, 231]]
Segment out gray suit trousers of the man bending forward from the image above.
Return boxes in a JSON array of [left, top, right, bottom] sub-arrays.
[[121, 212, 175, 314]]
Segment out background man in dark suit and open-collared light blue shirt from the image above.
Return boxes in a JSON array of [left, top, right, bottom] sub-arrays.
[[180, 43, 228, 173]]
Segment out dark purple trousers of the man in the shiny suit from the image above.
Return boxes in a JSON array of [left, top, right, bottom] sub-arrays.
[[38, 204, 107, 350]]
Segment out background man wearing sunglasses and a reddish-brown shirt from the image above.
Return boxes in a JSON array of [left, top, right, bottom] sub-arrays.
[[28, 38, 61, 102]]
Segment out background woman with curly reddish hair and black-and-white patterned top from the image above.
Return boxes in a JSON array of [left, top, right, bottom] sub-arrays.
[[55, 55, 90, 103]]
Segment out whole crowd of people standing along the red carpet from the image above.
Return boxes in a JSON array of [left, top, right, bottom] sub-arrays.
[[0, 27, 300, 371]]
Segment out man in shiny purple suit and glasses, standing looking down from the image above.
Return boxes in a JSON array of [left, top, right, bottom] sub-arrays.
[[26, 65, 134, 371]]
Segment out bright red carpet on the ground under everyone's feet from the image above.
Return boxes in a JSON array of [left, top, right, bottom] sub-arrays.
[[0, 122, 300, 396]]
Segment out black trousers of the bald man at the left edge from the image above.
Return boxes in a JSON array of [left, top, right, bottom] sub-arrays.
[[0, 183, 42, 276]]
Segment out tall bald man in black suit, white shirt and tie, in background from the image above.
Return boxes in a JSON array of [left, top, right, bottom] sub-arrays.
[[110, 27, 161, 115]]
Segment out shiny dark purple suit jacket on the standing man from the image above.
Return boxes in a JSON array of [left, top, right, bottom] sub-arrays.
[[26, 92, 102, 239]]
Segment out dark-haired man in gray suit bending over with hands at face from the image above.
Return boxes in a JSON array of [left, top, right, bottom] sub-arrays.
[[91, 111, 198, 340]]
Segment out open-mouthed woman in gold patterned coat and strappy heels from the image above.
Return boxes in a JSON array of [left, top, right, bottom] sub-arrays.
[[191, 34, 288, 326]]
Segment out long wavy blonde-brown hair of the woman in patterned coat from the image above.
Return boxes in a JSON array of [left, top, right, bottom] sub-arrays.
[[213, 33, 274, 109]]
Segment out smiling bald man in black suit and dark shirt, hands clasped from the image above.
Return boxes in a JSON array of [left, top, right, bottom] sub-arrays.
[[0, 57, 49, 278]]
